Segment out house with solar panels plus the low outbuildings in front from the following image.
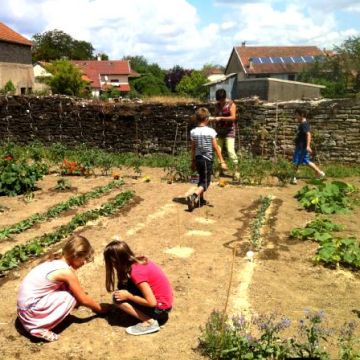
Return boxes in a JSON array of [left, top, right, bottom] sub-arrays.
[[205, 43, 327, 101]]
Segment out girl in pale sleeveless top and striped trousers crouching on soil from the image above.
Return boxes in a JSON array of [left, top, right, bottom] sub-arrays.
[[17, 235, 110, 341]]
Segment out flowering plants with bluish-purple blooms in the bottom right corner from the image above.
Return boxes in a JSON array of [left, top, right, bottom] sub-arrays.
[[198, 311, 360, 360]]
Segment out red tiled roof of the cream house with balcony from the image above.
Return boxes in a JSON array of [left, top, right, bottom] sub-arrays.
[[71, 60, 132, 88]]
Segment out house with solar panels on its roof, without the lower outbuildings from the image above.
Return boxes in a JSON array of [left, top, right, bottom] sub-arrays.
[[225, 43, 326, 80]]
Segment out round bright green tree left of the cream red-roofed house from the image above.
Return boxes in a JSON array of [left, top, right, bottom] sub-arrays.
[[43, 60, 87, 96]]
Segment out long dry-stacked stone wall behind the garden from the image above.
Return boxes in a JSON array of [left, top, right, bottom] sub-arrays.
[[0, 96, 360, 163]]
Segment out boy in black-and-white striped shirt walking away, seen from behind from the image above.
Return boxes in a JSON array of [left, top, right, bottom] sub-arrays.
[[187, 108, 227, 211]]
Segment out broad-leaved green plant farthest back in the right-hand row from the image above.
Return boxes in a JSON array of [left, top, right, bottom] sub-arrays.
[[295, 180, 355, 214]]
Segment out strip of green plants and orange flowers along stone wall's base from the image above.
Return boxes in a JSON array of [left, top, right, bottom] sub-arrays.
[[0, 141, 360, 190]]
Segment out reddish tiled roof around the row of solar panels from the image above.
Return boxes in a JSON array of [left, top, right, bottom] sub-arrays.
[[234, 46, 324, 74]]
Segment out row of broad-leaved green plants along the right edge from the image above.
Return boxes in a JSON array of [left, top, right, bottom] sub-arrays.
[[290, 180, 360, 270]]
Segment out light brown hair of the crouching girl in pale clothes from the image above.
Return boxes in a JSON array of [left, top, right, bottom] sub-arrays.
[[47, 234, 94, 261]]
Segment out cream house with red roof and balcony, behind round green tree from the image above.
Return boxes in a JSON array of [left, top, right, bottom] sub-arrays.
[[71, 60, 140, 97]]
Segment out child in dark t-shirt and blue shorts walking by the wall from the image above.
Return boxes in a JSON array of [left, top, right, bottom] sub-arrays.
[[292, 108, 325, 184]]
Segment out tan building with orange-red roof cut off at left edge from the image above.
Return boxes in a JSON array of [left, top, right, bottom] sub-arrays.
[[0, 22, 34, 95]]
